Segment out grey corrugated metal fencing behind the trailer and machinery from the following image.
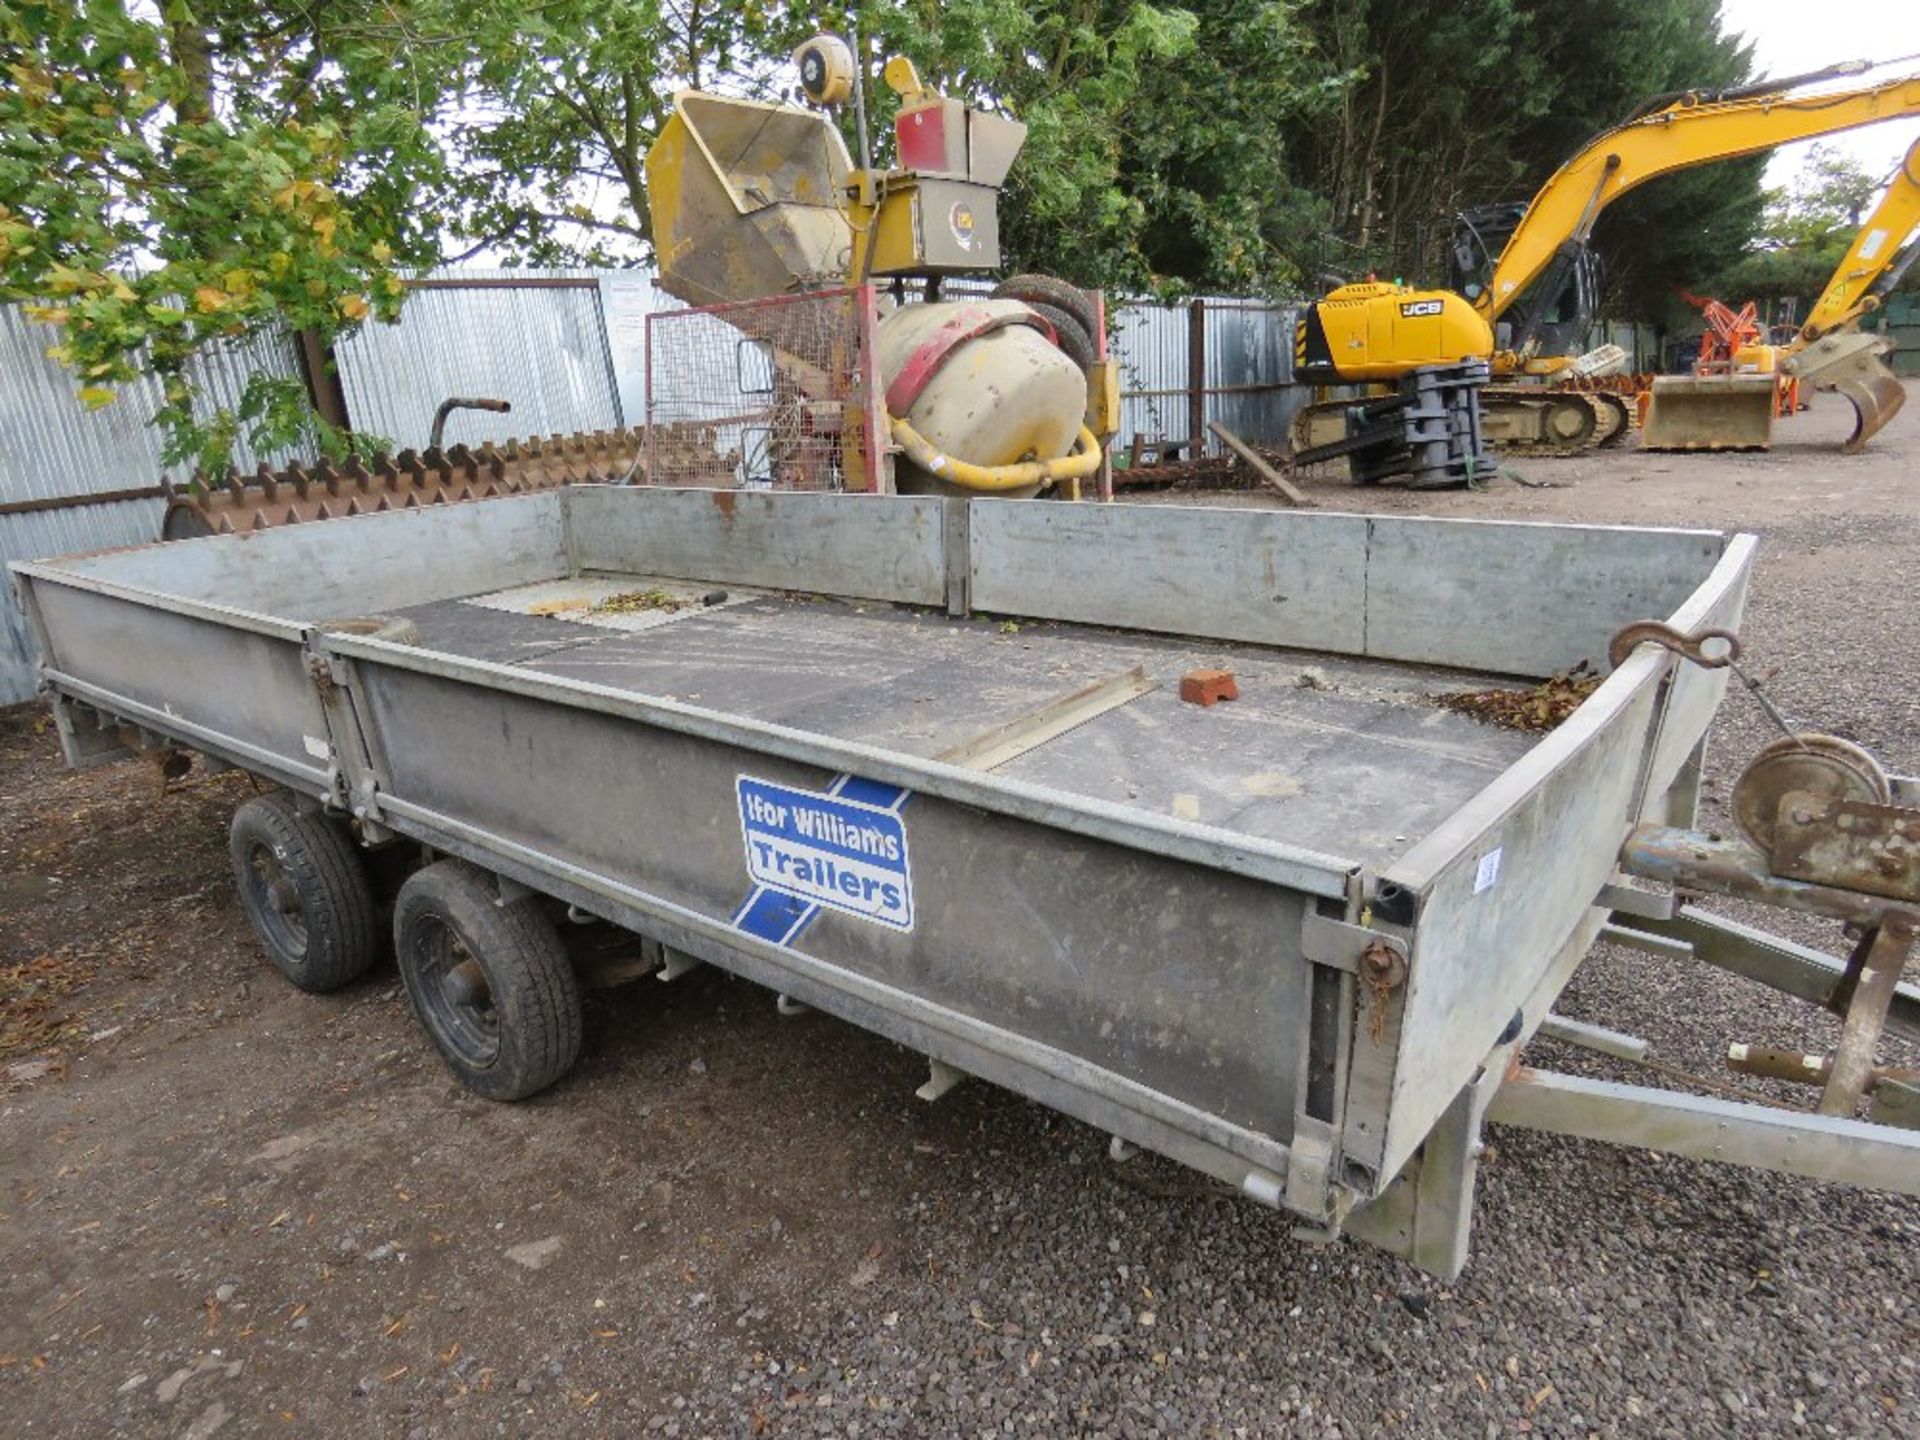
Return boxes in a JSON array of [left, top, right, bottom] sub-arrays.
[[0, 269, 1300, 705]]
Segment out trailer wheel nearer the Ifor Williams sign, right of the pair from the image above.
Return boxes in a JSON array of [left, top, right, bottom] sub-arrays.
[[394, 860, 580, 1100]]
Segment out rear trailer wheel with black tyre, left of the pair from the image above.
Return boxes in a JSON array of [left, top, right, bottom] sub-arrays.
[[228, 791, 382, 995]]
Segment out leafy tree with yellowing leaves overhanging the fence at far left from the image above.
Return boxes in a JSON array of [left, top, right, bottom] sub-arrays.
[[0, 0, 442, 470]]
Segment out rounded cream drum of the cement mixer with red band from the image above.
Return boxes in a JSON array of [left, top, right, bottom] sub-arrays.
[[874, 300, 1087, 499]]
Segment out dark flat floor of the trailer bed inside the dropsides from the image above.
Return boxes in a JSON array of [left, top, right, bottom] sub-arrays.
[[405, 576, 1536, 866]]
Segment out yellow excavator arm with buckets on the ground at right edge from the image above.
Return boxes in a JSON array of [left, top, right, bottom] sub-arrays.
[[1642, 140, 1920, 455]]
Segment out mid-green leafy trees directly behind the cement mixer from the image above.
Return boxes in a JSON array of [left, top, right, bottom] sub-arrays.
[[434, 0, 1244, 286]]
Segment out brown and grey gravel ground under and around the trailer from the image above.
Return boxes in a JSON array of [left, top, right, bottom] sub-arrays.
[[0, 389, 1920, 1440]]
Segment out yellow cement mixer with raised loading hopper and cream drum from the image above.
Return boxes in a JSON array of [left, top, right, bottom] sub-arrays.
[[647, 36, 1119, 497]]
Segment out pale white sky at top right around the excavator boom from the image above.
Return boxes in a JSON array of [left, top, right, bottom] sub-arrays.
[[1720, 0, 1920, 186]]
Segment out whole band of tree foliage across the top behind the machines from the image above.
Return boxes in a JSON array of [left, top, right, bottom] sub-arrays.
[[0, 0, 1781, 465]]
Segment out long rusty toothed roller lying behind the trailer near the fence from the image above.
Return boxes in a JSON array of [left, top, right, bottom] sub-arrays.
[[161, 430, 652, 540]]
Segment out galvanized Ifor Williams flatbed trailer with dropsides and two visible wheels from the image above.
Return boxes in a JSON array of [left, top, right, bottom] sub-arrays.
[[15, 488, 1920, 1275]]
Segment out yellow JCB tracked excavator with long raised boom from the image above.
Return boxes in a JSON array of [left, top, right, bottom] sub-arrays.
[[1294, 61, 1920, 488]]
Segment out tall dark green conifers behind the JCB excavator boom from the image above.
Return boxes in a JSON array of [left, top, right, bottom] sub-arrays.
[[1286, 0, 1759, 315]]
